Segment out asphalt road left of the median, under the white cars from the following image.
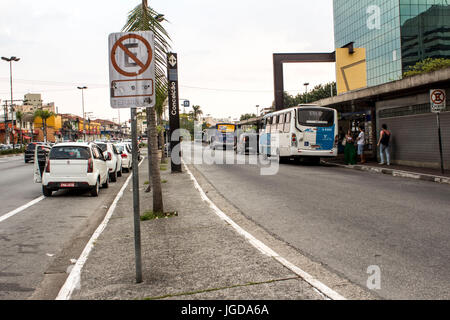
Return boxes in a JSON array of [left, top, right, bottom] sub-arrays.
[[0, 157, 132, 300]]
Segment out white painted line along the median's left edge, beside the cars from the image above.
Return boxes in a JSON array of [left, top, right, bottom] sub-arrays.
[[55, 157, 145, 300]]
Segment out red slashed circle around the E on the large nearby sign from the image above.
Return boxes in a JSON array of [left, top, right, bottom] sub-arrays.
[[111, 34, 153, 77]]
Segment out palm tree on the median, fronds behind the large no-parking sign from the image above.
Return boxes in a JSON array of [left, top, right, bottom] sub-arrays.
[[122, 0, 170, 212]]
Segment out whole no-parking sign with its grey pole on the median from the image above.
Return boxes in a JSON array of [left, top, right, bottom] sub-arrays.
[[109, 31, 155, 283]]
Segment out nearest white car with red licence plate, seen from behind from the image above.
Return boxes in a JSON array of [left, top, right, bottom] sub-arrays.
[[42, 142, 109, 197]]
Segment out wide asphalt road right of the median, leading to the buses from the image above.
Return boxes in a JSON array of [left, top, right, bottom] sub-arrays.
[[183, 145, 450, 299]]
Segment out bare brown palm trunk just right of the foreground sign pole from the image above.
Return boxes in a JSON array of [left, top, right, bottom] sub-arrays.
[[147, 108, 164, 212]]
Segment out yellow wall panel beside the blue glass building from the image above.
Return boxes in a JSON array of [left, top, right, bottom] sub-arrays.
[[336, 48, 367, 94]]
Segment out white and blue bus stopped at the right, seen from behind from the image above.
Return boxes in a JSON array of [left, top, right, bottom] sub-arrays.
[[259, 104, 338, 163]]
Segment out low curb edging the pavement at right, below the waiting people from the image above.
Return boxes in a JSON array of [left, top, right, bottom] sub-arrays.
[[322, 161, 450, 184]]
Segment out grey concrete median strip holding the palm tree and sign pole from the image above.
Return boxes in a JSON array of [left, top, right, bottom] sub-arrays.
[[72, 160, 324, 300]]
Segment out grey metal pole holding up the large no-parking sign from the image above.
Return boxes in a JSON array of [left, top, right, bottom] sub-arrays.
[[131, 108, 142, 283]]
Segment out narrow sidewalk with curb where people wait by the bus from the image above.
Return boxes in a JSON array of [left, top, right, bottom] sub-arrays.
[[322, 158, 450, 184]]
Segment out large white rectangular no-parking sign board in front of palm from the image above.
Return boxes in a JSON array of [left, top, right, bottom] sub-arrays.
[[109, 31, 155, 109]]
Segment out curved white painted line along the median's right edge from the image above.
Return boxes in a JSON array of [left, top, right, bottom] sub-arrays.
[[183, 162, 347, 300]]
